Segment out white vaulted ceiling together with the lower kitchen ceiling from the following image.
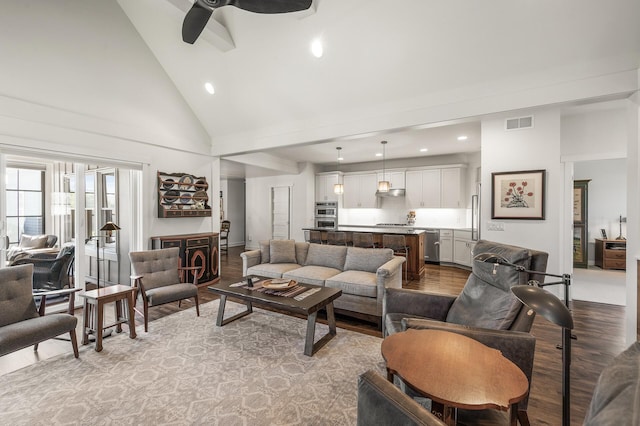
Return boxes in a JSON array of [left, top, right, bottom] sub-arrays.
[[118, 0, 640, 176]]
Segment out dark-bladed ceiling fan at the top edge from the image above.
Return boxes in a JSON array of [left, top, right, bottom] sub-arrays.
[[182, 0, 312, 44]]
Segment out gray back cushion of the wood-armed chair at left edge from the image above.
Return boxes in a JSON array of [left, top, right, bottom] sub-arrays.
[[0, 264, 39, 327]]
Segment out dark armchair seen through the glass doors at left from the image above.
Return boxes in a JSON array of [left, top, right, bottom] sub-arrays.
[[13, 245, 75, 290]]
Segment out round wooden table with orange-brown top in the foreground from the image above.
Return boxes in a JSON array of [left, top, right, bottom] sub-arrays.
[[382, 329, 529, 425]]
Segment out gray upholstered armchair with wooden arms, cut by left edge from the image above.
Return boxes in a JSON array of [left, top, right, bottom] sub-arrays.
[[0, 265, 78, 358]]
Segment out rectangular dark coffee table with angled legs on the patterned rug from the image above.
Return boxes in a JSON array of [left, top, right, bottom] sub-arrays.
[[207, 278, 342, 356]]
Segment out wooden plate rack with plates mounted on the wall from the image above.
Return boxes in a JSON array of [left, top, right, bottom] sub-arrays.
[[158, 171, 211, 218]]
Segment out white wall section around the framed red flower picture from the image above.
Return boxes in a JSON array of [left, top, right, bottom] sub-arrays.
[[481, 109, 567, 278]]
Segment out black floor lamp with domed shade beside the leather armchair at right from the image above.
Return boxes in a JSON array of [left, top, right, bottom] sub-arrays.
[[473, 253, 573, 426]]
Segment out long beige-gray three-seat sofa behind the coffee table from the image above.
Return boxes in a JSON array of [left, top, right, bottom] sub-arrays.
[[240, 240, 405, 326]]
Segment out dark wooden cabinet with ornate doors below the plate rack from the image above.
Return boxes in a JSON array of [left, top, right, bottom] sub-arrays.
[[151, 233, 220, 287]]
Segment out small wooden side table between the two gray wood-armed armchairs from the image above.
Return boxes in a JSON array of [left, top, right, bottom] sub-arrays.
[[80, 284, 136, 352]]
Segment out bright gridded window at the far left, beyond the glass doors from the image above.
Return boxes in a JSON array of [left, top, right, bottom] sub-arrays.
[[6, 166, 45, 244]]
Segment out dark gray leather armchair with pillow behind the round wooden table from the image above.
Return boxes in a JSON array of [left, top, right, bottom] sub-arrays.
[[383, 240, 548, 424]]
